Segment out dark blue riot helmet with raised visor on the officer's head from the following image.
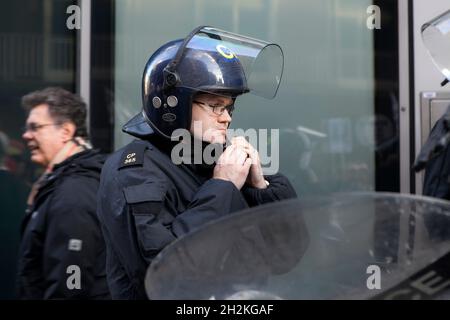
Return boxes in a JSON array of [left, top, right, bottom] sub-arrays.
[[122, 27, 283, 139]]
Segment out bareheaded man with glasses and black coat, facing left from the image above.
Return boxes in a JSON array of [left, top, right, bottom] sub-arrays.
[[17, 88, 110, 299]]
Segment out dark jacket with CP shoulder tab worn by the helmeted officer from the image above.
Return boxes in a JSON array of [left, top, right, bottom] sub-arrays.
[[97, 140, 296, 299]]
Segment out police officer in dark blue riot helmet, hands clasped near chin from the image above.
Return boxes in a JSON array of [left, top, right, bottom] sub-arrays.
[[97, 27, 296, 299]]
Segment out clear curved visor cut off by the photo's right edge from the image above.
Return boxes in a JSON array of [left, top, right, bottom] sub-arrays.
[[422, 10, 450, 84]]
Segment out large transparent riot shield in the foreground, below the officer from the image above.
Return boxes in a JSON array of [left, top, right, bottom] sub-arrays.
[[145, 193, 450, 300]]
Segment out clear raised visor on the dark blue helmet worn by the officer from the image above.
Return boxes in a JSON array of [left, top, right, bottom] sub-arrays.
[[173, 27, 283, 99]]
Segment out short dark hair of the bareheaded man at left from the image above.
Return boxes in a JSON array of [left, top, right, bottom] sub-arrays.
[[22, 87, 88, 138]]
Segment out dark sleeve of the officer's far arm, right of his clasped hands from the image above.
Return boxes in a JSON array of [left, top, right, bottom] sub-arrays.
[[242, 174, 297, 207]]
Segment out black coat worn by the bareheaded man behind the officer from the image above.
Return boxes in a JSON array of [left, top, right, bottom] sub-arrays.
[[17, 150, 110, 299]]
